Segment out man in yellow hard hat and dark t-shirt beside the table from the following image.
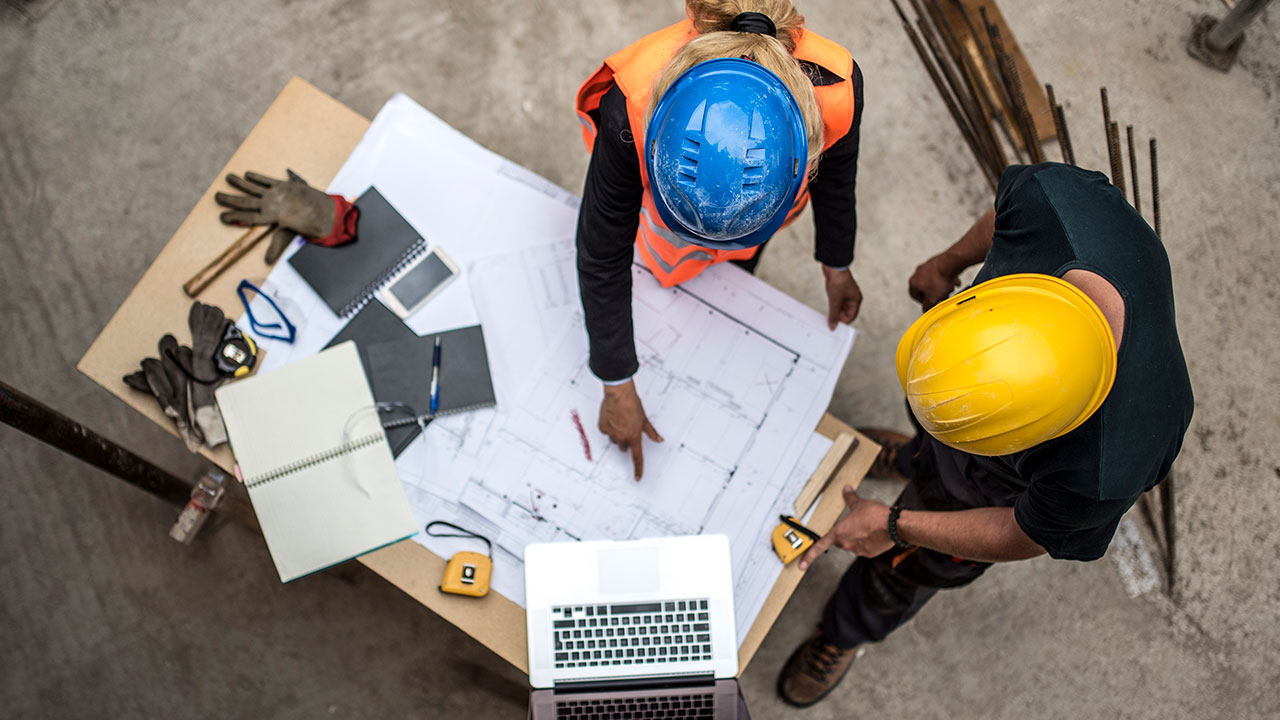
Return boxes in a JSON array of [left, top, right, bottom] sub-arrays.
[[778, 163, 1194, 706]]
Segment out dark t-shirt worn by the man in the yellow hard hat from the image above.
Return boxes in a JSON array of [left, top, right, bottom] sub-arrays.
[[970, 163, 1196, 560]]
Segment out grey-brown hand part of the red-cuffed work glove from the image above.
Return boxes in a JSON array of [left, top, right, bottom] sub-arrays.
[[214, 170, 335, 264]]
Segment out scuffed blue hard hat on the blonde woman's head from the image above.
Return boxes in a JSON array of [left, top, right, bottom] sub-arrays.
[[645, 58, 809, 250]]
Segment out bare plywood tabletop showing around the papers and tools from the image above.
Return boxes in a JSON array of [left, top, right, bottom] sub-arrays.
[[77, 78, 878, 671]]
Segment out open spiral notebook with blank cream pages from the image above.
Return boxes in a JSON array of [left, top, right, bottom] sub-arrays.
[[215, 342, 416, 583]]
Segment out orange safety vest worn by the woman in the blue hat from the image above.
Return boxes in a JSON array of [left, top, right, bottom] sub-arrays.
[[577, 20, 854, 287]]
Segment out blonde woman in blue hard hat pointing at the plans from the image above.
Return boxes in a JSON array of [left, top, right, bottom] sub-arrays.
[[577, 0, 863, 479]]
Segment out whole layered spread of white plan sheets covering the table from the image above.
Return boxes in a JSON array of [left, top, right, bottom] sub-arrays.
[[242, 96, 855, 642]]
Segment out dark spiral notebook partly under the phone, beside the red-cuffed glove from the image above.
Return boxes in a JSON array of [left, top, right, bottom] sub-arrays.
[[289, 187, 426, 318]]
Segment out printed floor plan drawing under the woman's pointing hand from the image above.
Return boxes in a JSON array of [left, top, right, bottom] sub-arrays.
[[397, 241, 854, 634]]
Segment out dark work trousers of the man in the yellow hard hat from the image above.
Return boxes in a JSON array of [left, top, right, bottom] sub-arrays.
[[822, 411, 1019, 648]]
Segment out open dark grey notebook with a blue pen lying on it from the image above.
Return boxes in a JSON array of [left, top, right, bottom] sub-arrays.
[[325, 302, 497, 456]]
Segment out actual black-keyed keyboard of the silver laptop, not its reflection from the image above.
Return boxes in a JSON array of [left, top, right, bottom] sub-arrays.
[[552, 598, 712, 666]]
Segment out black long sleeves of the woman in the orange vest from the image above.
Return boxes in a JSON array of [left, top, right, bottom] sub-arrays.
[[577, 64, 863, 382]]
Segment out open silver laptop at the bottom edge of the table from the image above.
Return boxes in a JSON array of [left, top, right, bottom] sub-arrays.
[[525, 536, 749, 720]]
